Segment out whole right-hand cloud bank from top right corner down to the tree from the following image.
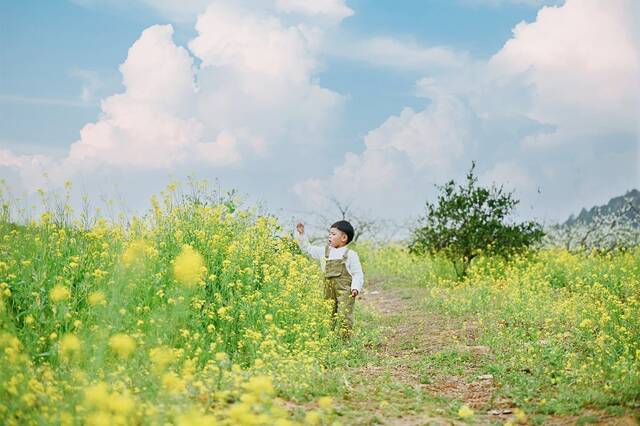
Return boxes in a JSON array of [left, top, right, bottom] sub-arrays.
[[294, 0, 640, 220]]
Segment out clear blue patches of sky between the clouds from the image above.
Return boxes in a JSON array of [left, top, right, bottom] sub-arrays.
[[0, 0, 537, 151]]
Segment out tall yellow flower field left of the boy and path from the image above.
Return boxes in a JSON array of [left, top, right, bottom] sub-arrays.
[[0, 188, 348, 425]]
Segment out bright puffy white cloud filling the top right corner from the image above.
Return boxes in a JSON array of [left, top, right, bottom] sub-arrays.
[[489, 0, 640, 131]]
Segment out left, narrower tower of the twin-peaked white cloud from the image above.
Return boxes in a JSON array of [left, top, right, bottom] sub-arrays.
[[67, 25, 202, 168]]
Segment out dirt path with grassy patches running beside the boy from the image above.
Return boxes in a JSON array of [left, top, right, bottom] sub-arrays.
[[332, 281, 513, 425]]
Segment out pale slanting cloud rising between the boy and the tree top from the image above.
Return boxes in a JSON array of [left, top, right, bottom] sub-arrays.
[[294, 97, 474, 216]]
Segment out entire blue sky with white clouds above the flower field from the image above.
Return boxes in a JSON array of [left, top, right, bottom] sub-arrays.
[[0, 0, 640, 233]]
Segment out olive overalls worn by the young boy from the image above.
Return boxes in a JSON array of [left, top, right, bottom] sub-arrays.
[[324, 245, 355, 338]]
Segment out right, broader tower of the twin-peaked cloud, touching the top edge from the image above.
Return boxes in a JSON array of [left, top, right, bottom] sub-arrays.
[[189, 4, 343, 152]]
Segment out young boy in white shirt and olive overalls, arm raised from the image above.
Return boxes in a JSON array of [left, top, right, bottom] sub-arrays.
[[296, 220, 364, 338]]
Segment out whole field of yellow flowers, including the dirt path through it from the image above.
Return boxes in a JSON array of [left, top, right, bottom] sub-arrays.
[[0, 188, 640, 425]]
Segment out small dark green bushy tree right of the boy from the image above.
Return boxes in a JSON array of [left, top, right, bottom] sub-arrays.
[[409, 162, 544, 278]]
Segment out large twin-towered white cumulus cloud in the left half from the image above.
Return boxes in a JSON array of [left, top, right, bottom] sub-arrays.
[[3, 1, 343, 192]]
